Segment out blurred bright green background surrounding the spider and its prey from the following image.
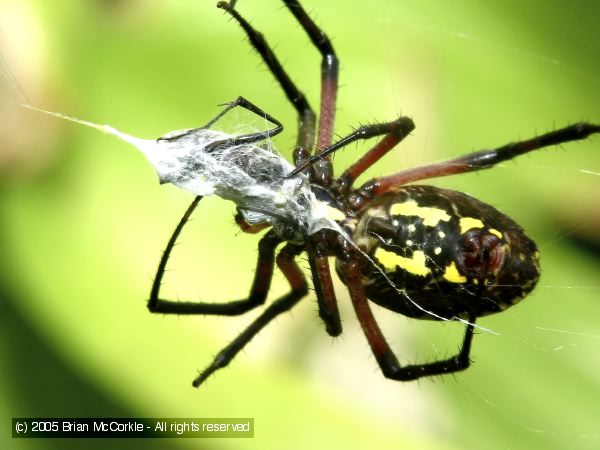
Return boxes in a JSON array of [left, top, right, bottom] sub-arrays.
[[0, 0, 600, 449]]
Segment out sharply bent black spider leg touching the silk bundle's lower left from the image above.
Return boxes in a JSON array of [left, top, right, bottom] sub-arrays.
[[148, 196, 282, 316]]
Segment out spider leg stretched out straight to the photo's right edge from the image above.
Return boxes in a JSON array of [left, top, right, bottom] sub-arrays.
[[350, 123, 600, 209]]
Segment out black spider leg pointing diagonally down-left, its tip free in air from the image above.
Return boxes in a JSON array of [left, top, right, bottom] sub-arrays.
[[192, 244, 308, 387]]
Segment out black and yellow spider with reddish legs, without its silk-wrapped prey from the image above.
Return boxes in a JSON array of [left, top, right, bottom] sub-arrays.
[[148, 0, 600, 387]]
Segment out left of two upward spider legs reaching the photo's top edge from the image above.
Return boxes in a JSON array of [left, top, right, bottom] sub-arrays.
[[217, 2, 316, 164]]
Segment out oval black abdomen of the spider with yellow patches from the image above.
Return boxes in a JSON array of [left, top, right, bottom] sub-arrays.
[[344, 186, 539, 320]]
